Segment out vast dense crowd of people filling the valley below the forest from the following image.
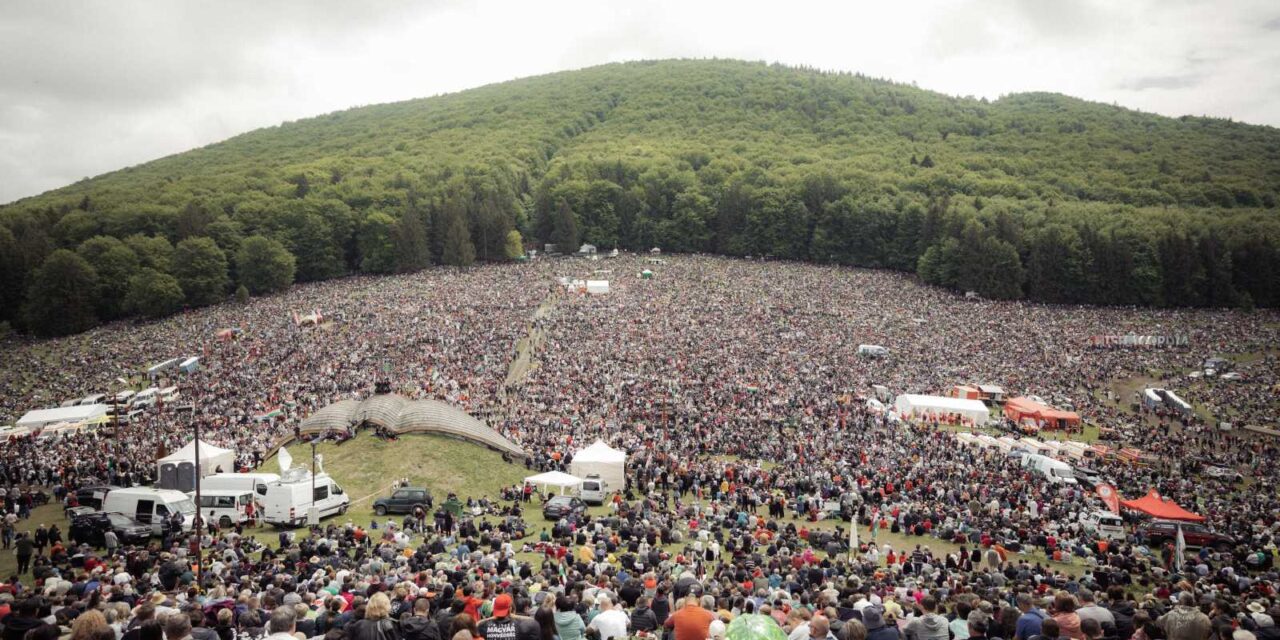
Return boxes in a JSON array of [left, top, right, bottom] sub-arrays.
[[0, 256, 1280, 640]]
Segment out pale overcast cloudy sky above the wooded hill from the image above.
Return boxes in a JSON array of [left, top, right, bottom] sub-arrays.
[[0, 0, 1280, 202]]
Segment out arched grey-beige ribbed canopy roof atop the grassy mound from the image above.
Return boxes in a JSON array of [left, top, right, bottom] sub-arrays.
[[300, 394, 525, 458]]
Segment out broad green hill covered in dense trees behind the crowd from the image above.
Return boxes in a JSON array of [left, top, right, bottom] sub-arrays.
[[0, 60, 1280, 333]]
